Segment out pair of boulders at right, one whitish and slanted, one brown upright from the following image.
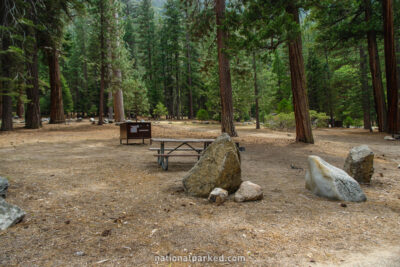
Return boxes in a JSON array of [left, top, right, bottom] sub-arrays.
[[305, 145, 374, 202]]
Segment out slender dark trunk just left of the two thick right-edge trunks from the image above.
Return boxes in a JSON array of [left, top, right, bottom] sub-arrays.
[[359, 45, 371, 130]]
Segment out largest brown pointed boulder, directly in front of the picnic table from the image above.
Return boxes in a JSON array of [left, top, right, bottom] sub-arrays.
[[183, 133, 242, 197]]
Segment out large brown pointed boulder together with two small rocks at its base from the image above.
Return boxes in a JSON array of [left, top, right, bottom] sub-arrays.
[[183, 133, 263, 204]]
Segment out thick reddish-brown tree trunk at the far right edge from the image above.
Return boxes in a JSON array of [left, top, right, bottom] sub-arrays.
[[382, 0, 399, 134]]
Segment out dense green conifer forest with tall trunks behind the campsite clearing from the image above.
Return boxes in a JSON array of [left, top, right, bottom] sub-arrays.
[[0, 0, 400, 143]]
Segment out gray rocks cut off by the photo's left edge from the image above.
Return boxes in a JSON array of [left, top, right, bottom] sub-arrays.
[[0, 177, 25, 230]]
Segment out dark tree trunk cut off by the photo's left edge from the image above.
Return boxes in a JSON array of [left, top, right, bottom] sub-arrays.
[[0, 33, 13, 131]]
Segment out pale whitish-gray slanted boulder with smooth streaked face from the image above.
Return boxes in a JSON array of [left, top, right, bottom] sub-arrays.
[[305, 156, 367, 202]]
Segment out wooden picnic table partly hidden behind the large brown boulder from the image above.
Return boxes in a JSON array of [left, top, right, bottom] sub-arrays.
[[150, 138, 215, 171]]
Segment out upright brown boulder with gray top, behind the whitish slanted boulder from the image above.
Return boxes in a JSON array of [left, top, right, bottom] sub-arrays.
[[344, 145, 374, 184]]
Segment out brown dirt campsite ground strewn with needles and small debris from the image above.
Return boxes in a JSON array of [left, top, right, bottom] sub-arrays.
[[0, 121, 400, 266]]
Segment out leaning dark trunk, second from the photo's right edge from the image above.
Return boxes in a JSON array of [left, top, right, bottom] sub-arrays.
[[364, 0, 387, 132]]
